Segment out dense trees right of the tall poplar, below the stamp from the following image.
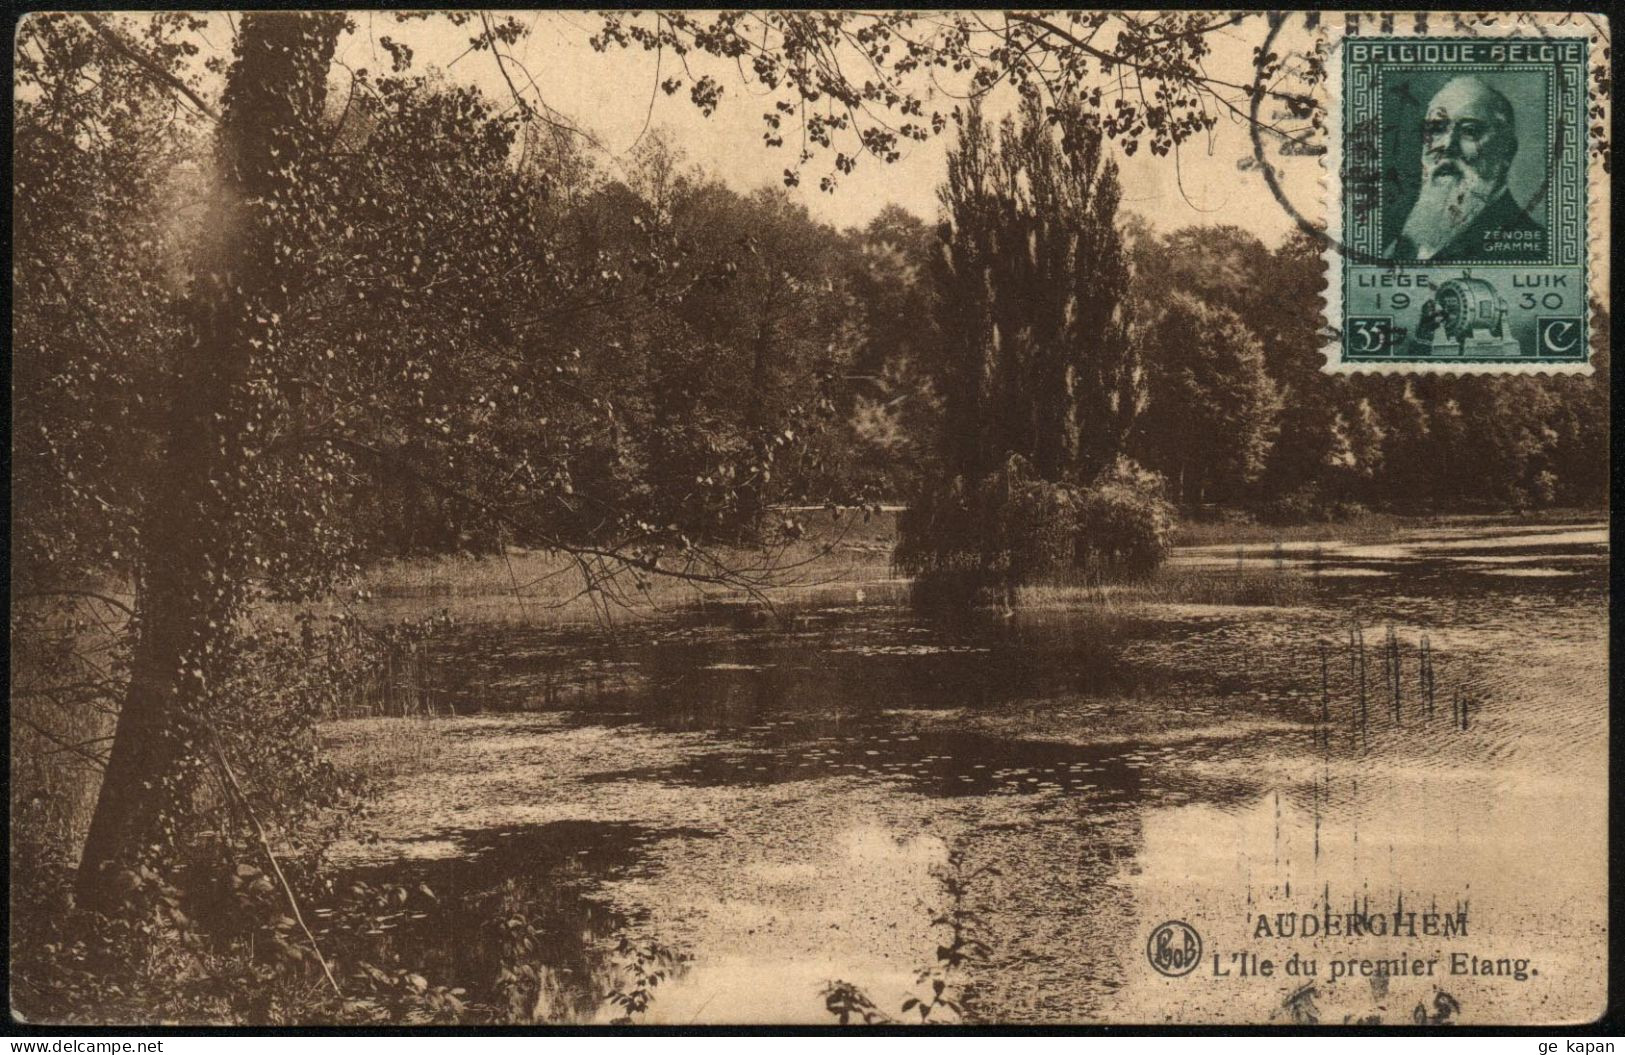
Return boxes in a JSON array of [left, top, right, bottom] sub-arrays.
[[1129, 223, 1609, 520]]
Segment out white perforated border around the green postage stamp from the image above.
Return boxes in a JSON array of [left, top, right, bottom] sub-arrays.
[[1320, 11, 1614, 377]]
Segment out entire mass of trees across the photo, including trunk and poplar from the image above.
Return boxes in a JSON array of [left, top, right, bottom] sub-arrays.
[[13, 13, 1609, 923]]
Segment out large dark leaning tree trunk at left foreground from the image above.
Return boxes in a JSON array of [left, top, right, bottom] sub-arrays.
[[78, 13, 343, 910]]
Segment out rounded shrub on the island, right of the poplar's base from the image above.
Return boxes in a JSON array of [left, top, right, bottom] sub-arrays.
[[1074, 457, 1173, 579]]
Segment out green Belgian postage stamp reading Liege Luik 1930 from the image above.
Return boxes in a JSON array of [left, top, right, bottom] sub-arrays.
[[1326, 26, 1596, 372]]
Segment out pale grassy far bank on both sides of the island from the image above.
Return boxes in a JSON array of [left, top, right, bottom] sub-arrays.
[[333, 509, 1602, 626]]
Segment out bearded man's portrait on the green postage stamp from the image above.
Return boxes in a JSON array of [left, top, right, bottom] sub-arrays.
[[1385, 76, 1545, 260]]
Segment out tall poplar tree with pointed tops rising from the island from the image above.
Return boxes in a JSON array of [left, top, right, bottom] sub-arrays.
[[936, 99, 1144, 483]]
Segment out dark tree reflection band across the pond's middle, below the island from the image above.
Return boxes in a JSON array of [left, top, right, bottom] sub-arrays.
[[436, 608, 1176, 718]]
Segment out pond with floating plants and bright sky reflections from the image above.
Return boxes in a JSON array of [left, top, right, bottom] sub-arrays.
[[328, 523, 1609, 1024]]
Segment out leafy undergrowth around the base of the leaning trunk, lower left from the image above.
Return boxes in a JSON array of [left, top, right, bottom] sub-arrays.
[[11, 610, 460, 1024]]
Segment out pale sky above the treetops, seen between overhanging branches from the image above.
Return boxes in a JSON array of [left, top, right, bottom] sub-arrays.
[[305, 11, 1320, 244]]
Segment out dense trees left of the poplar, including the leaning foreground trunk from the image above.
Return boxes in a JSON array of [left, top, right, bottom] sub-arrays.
[[13, 15, 942, 910]]
